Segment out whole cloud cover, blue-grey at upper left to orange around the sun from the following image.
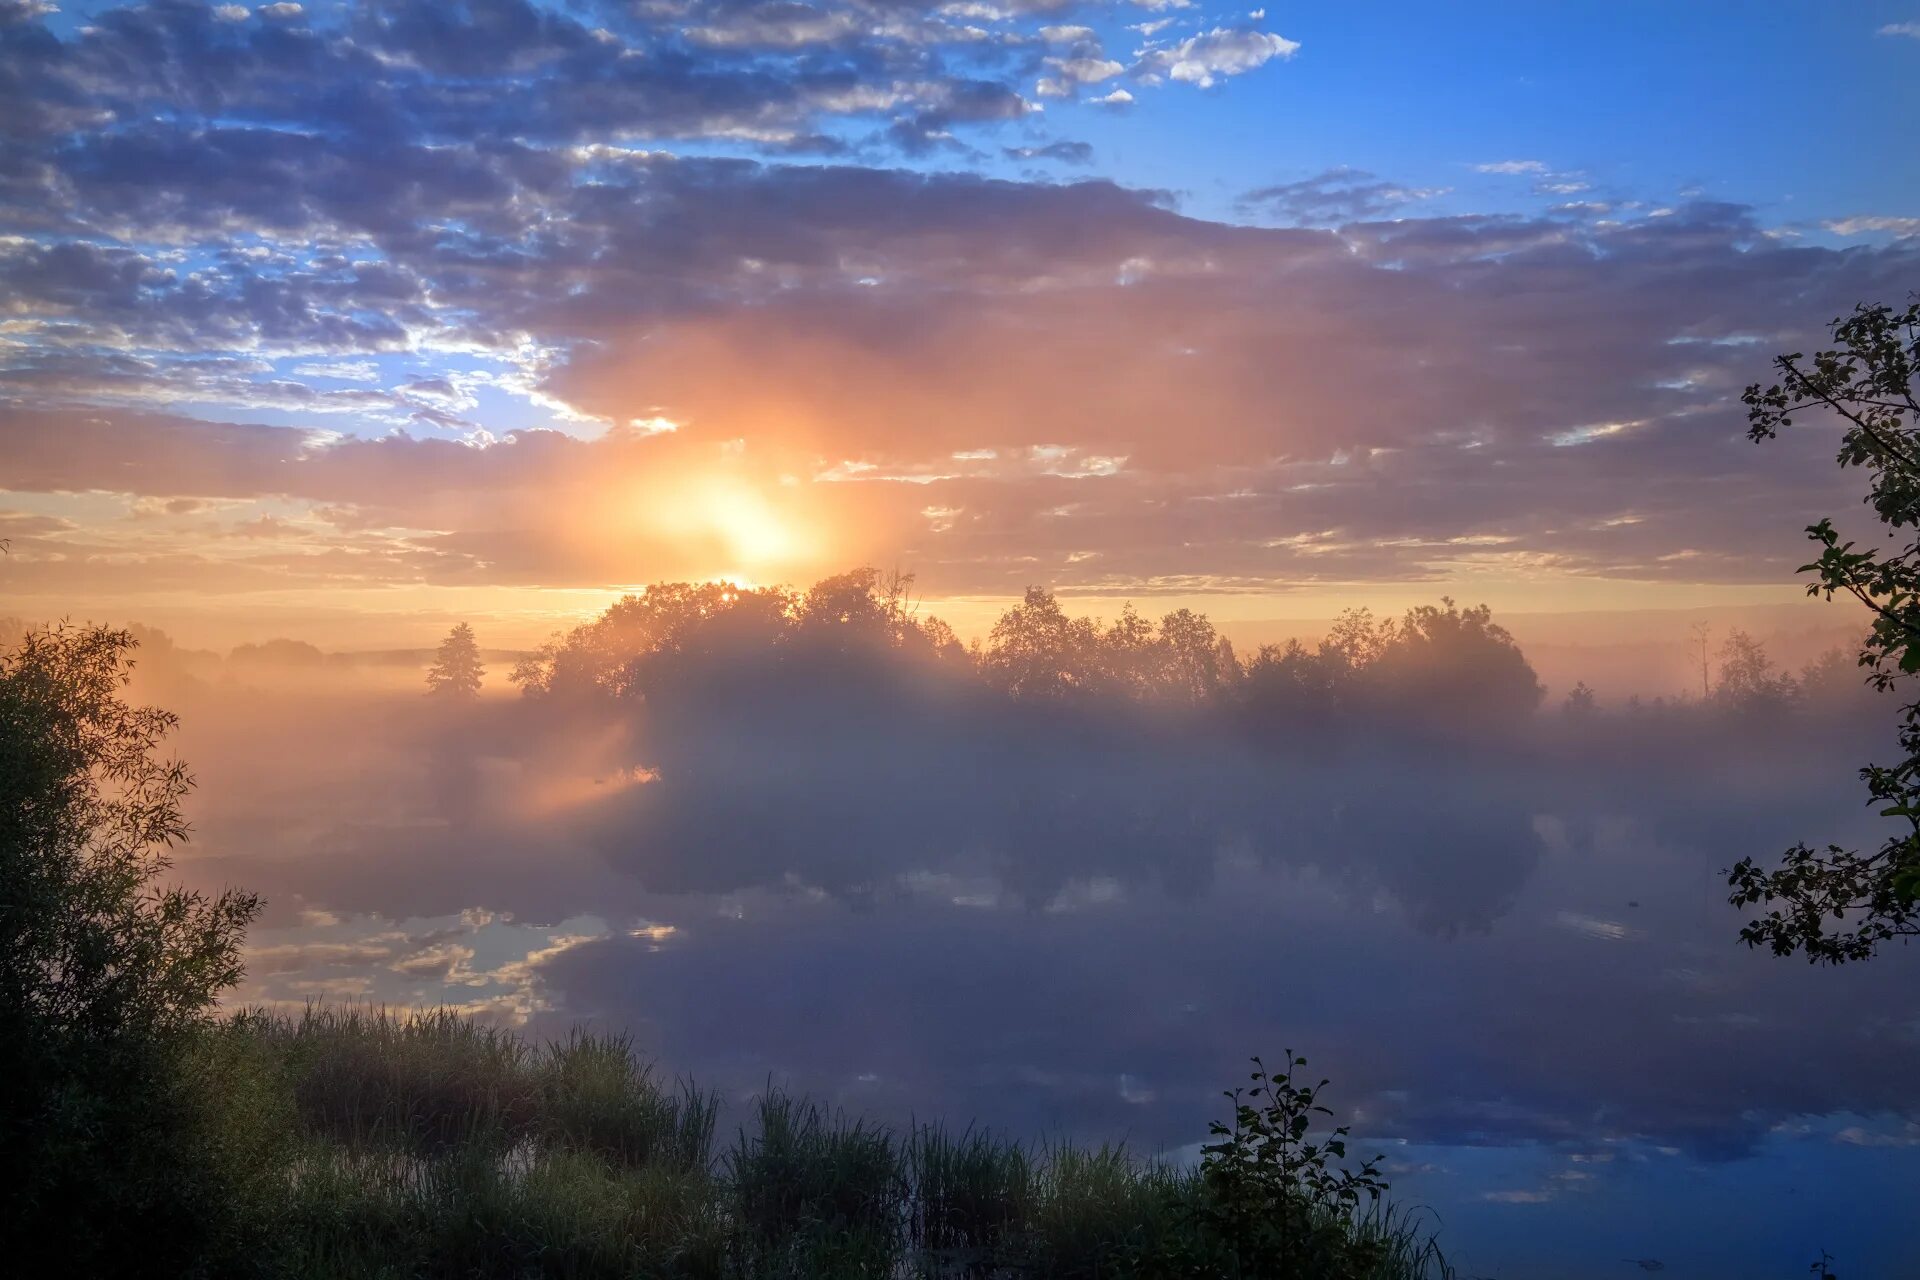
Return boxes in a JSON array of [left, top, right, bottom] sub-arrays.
[[0, 0, 1914, 610]]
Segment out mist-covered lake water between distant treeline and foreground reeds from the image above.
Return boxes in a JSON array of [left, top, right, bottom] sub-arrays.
[[86, 610, 1920, 1276]]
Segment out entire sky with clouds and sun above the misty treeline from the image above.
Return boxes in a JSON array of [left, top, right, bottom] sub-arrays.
[[0, 0, 1920, 647]]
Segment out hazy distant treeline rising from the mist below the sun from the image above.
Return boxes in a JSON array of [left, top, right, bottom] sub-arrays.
[[511, 568, 1860, 727]]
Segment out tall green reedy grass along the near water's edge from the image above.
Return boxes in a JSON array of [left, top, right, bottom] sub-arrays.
[[172, 1007, 1450, 1280]]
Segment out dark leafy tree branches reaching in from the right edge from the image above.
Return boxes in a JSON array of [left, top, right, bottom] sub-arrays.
[[1728, 303, 1920, 963]]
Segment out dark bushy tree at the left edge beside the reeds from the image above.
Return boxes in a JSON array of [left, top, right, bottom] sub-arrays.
[[0, 628, 259, 1274]]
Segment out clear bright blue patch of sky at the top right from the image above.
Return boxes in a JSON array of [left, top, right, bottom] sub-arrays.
[[1087, 4, 1920, 225]]
